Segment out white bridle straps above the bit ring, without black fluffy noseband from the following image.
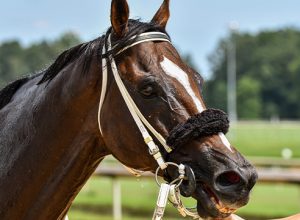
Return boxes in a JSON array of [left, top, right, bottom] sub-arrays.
[[98, 32, 172, 169]]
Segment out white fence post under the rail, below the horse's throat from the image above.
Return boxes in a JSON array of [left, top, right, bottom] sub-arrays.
[[112, 177, 122, 220]]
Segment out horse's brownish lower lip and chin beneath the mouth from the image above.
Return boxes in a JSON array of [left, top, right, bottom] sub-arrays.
[[193, 184, 236, 218]]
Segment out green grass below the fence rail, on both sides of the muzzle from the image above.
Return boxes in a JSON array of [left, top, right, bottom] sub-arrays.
[[69, 177, 300, 220]]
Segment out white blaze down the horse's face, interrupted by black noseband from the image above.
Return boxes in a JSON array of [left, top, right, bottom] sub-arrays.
[[160, 57, 232, 151]]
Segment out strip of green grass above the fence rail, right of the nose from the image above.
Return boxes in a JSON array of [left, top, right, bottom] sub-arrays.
[[227, 122, 300, 157]]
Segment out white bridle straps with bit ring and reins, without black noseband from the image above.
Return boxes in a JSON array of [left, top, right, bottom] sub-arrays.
[[98, 32, 200, 220]]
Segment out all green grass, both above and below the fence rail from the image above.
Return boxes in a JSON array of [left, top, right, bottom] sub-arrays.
[[69, 122, 300, 220]]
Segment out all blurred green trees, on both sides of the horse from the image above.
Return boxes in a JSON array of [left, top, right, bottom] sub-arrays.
[[0, 29, 300, 119]]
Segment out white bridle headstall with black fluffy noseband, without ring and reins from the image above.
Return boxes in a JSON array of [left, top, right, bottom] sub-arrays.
[[98, 32, 229, 170]]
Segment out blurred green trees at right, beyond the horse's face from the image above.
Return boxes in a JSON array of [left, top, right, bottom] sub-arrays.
[[204, 28, 300, 119]]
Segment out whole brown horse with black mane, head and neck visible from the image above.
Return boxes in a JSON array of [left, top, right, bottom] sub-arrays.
[[0, 0, 257, 220]]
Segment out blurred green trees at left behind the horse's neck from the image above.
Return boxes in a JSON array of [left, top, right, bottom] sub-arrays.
[[0, 32, 81, 88]]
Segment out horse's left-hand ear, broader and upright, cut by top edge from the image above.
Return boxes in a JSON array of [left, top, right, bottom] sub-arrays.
[[110, 0, 129, 37]]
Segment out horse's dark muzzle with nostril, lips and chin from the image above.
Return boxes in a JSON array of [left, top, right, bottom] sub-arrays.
[[192, 153, 257, 218]]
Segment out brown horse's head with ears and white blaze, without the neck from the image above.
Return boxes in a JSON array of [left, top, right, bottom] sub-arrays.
[[99, 0, 257, 218]]
